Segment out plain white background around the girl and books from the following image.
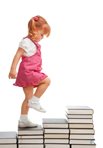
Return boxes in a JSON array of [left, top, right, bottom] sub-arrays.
[[0, 0, 103, 148]]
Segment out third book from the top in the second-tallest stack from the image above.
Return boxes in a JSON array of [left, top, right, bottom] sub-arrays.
[[44, 134, 69, 139]]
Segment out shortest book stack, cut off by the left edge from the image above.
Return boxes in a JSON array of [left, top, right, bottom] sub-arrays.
[[0, 132, 17, 148]]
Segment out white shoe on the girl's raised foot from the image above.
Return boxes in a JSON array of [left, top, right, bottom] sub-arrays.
[[28, 100, 46, 113]]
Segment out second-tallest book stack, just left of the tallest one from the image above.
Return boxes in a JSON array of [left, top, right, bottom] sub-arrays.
[[43, 118, 70, 148]]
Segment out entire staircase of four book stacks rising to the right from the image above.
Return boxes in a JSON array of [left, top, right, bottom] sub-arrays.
[[0, 106, 96, 148]]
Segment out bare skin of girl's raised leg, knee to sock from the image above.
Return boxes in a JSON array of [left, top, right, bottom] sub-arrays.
[[34, 77, 50, 98]]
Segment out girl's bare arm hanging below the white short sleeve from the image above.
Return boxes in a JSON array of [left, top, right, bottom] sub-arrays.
[[8, 48, 25, 79]]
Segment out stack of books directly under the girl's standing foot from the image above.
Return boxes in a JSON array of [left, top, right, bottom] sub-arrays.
[[18, 126, 44, 148]]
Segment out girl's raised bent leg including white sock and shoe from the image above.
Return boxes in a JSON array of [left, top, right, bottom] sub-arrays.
[[29, 78, 50, 112]]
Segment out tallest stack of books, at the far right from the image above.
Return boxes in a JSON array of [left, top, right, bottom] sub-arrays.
[[66, 106, 96, 148]]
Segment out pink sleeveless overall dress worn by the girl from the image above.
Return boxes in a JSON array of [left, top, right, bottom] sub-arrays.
[[14, 37, 47, 87]]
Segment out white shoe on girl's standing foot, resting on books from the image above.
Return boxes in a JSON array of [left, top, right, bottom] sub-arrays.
[[18, 120, 38, 127]]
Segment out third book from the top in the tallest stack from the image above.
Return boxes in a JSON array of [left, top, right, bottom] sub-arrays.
[[67, 119, 93, 124]]
